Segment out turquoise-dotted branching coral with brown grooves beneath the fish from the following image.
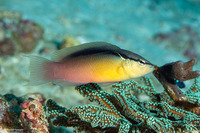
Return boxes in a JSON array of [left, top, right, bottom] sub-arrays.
[[47, 77, 200, 133]]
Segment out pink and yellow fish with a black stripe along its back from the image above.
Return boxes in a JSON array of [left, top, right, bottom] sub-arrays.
[[28, 42, 154, 86]]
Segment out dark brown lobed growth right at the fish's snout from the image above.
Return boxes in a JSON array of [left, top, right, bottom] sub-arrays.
[[153, 59, 200, 115]]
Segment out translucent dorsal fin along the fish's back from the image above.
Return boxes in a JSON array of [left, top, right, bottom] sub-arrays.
[[51, 42, 120, 61]]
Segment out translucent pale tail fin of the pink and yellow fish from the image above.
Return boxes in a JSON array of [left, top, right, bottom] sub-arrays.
[[27, 56, 51, 86]]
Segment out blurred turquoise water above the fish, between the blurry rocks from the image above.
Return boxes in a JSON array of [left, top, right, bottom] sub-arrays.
[[0, 0, 200, 64]]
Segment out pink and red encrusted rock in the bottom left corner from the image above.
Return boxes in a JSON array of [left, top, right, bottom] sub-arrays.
[[0, 93, 49, 133]]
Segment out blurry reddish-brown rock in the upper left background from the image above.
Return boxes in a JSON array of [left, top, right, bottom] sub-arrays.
[[0, 10, 44, 55]]
